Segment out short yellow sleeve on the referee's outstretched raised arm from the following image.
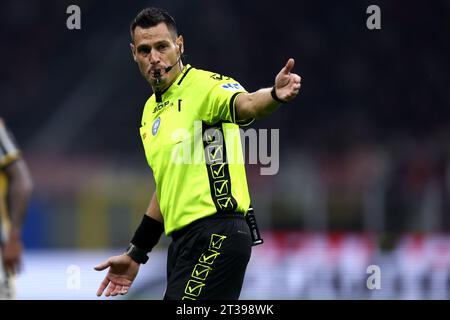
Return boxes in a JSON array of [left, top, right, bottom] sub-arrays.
[[208, 78, 253, 125]]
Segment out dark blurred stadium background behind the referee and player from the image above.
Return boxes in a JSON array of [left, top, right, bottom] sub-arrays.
[[0, 0, 450, 299]]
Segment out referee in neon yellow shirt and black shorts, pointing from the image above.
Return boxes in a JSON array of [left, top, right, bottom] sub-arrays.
[[95, 8, 300, 300]]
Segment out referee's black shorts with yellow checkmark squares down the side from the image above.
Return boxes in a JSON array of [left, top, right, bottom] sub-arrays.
[[164, 213, 252, 300]]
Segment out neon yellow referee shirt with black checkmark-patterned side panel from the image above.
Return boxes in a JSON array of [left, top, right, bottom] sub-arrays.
[[140, 65, 250, 235]]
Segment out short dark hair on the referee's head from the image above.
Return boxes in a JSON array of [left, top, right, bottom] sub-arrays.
[[130, 7, 178, 41]]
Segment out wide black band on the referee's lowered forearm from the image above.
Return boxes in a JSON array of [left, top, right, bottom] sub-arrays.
[[127, 214, 164, 263]]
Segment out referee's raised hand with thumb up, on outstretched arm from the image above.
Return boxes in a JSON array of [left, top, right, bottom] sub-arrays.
[[275, 58, 302, 102]]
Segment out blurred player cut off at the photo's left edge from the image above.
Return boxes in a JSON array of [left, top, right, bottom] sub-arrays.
[[0, 119, 33, 300]]
